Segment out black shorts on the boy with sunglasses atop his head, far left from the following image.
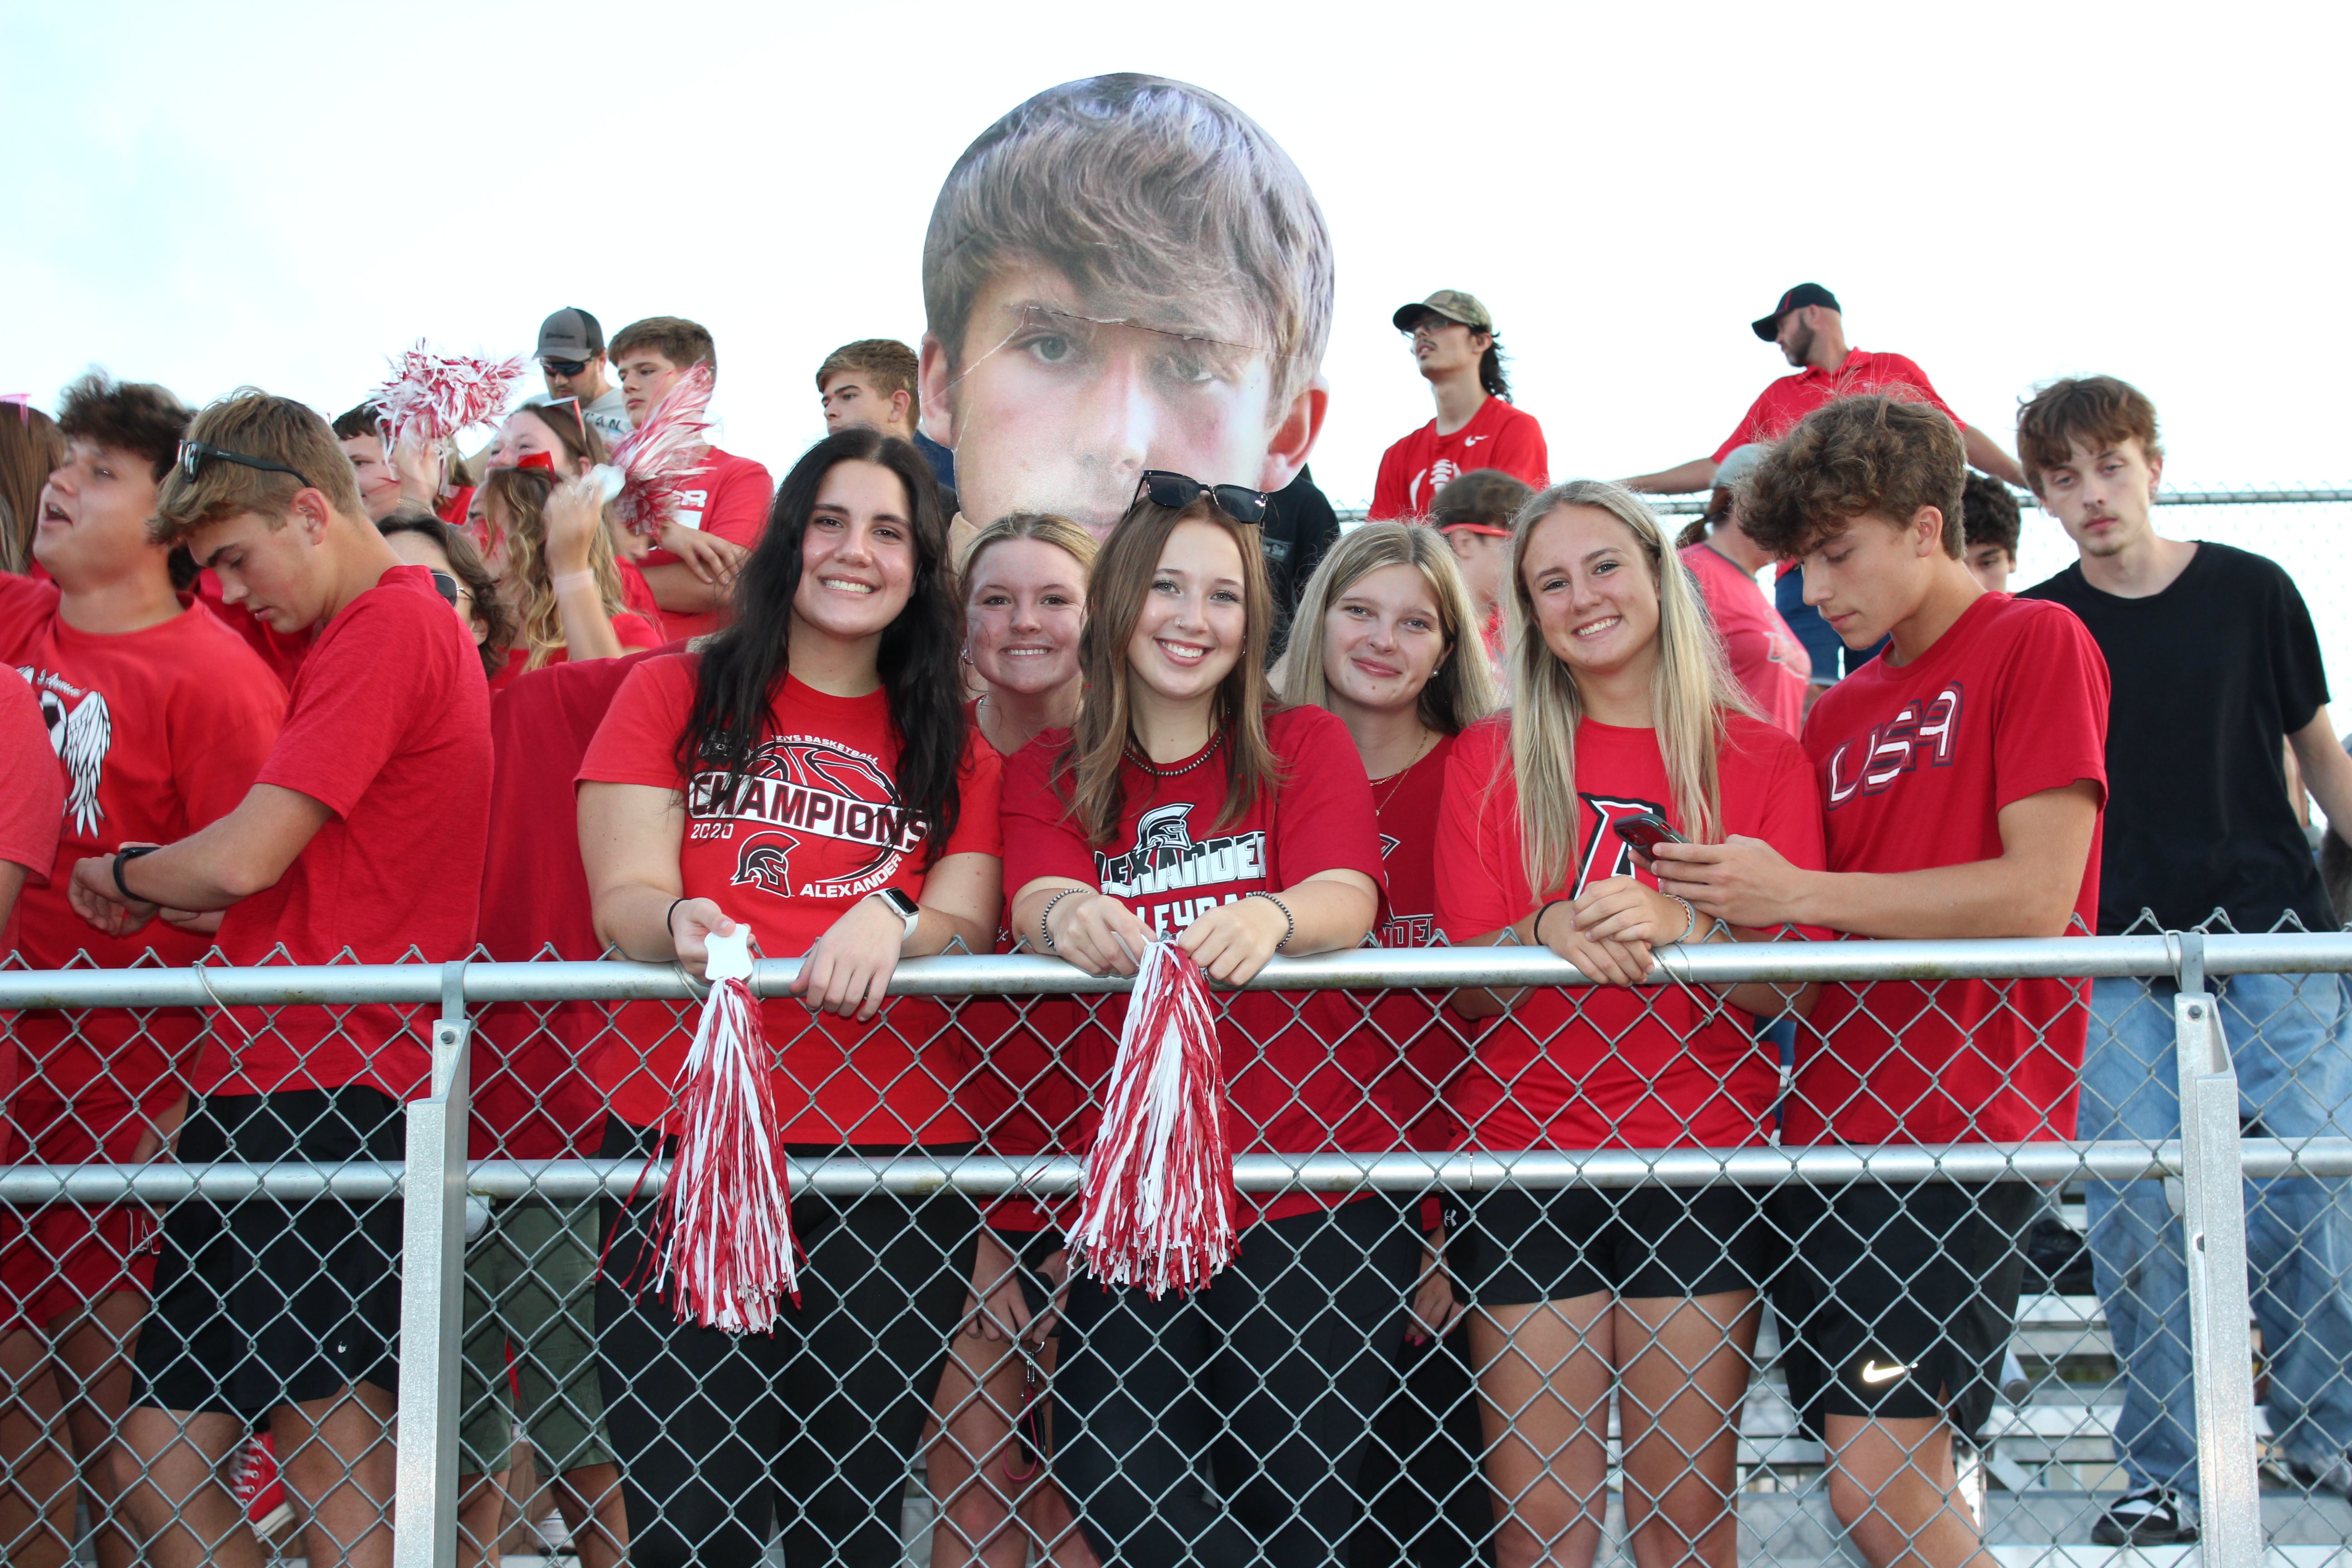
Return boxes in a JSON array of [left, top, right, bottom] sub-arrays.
[[132, 1084, 405, 1417]]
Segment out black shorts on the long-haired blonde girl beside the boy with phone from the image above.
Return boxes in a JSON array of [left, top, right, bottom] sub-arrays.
[[1446, 1187, 1771, 1307]]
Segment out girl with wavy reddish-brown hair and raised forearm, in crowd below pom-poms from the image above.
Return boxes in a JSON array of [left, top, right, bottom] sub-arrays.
[[468, 470, 661, 691]]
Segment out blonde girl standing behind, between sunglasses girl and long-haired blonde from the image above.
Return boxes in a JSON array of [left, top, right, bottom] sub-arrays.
[[1275, 522, 1498, 1561]]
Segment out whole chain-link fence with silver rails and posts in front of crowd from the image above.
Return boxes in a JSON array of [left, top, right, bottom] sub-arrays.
[[0, 933, 2352, 1568]]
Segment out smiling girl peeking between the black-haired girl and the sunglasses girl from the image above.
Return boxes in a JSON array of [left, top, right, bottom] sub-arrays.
[[926, 513, 1098, 1568]]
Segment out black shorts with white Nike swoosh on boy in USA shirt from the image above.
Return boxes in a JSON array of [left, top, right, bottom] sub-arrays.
[[1764, 1180, 2042, 1436]]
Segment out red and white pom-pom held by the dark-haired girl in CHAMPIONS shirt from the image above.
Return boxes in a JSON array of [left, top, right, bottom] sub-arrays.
[[654, 931, 800, 1333]]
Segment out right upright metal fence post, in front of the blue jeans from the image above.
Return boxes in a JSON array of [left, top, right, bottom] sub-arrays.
[[2173, 931, 2263, 1568]]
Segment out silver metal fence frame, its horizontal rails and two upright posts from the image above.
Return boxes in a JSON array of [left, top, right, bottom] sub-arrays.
[[0, 933, 2352, 1568]]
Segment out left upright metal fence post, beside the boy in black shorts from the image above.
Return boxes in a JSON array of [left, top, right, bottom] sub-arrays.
[[393, 961, 473, 1568]]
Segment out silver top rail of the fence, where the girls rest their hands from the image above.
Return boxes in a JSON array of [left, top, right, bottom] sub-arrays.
[[0, 931, 2352, 1009]]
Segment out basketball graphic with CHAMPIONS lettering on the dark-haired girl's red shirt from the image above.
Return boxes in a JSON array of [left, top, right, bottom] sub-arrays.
[[687, 736, 922, 898]]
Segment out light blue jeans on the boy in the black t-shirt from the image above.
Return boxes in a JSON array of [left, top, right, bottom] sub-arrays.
[[2082, 975, 2352, 1495]]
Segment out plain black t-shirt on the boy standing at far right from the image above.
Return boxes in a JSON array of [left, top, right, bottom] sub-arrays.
[[2023, 543, 2336, 936]]
